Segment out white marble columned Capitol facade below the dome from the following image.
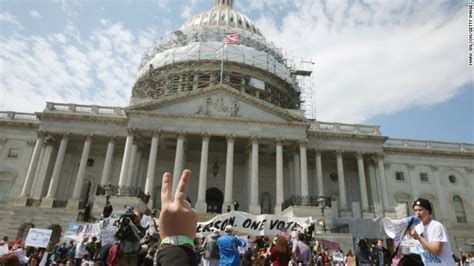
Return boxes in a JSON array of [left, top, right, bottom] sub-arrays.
[[0, 1, 474, 254]]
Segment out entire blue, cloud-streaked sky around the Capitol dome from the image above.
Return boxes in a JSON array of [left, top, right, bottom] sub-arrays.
[[0, 0, 474, 143]]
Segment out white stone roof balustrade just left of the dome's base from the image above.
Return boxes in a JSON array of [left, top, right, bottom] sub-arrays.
[[45, 102, 125, 116]]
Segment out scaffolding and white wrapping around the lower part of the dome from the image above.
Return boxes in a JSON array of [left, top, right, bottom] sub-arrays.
[[132, 38, 310, 109]]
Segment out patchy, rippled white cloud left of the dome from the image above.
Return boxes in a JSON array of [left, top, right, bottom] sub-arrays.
[[0, 22, 154, 112]]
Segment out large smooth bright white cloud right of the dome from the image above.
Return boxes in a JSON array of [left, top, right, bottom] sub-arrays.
[[257, 0, 471, 123]]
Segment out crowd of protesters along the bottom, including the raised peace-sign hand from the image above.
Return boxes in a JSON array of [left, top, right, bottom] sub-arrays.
[[0, 170, 473, 266]]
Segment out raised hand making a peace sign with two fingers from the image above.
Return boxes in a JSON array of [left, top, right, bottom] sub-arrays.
[[160, 169, 197, 239]]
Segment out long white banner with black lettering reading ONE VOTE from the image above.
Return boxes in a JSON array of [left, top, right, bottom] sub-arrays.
[[196, 211, 312, 237]]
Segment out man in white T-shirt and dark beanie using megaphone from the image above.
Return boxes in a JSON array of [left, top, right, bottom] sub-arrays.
[[409, 198, 455, 266]]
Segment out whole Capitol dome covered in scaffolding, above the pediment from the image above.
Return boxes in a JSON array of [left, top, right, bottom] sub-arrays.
[[131, 0, 300, 109]]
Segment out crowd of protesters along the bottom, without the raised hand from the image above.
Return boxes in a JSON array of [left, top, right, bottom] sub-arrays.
[[0, 223, 474, 266]]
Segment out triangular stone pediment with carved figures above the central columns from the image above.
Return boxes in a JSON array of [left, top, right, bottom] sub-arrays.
[[127, 85, 304, 122]]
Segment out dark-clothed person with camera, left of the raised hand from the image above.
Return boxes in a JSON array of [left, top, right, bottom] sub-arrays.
[[115, 211, 145, 266]]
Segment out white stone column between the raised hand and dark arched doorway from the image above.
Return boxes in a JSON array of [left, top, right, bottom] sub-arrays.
[[195, 133, 211, 213]]
